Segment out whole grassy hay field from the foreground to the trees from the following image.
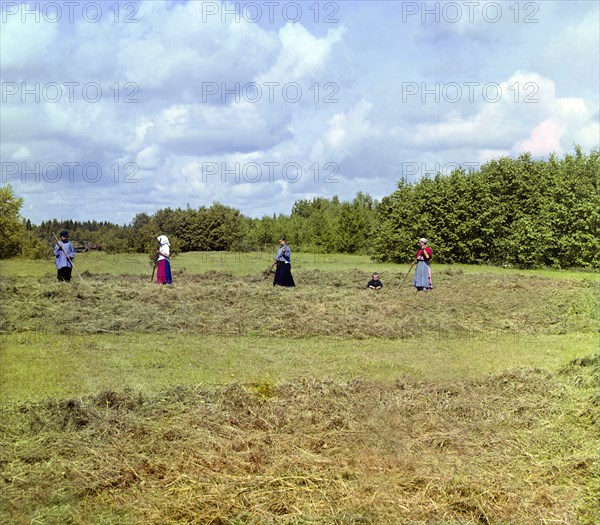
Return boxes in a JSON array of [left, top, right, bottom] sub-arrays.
[[0, 253, 600, 525]]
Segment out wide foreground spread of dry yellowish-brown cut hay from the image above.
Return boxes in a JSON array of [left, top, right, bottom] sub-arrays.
[[0, 357, 600, 525]]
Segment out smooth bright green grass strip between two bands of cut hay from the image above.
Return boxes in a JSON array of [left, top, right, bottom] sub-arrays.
[[0, 333, 598, 401]]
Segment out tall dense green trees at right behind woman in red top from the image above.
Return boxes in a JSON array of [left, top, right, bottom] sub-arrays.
[[371, 147, 600, 268]]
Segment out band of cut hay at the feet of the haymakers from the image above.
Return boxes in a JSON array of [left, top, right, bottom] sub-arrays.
[[0, 270, 598, 338]]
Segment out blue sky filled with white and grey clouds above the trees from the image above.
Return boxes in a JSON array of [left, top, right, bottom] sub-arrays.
[[0, 1, 600, 223]]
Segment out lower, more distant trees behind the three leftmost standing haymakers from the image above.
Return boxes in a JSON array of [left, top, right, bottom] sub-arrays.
[[0, 191, 377, 258]]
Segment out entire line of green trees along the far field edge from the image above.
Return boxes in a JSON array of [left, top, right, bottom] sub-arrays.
[[0, 146, 600, 268]]
